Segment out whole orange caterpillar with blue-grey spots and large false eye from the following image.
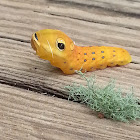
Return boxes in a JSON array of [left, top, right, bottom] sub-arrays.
[[31, 29, 131, 74]]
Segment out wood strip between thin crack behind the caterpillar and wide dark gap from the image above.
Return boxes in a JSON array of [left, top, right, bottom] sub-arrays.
[[0, 39, 140, 96]]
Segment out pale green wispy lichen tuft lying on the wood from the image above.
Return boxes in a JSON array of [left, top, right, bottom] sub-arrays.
[[66, 72, 140, 122]]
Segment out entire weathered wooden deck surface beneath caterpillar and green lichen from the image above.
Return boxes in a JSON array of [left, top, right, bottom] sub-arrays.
[[0, 0, 140, 140]]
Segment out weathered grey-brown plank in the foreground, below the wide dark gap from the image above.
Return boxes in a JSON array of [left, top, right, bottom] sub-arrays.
[[0, 84, 140, 140]]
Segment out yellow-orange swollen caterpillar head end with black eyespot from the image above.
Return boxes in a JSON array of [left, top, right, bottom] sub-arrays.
[[31, 29, 74, 62]]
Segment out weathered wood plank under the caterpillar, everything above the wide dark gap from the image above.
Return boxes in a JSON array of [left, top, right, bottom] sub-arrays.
[[0, 0, 140, 97]]
